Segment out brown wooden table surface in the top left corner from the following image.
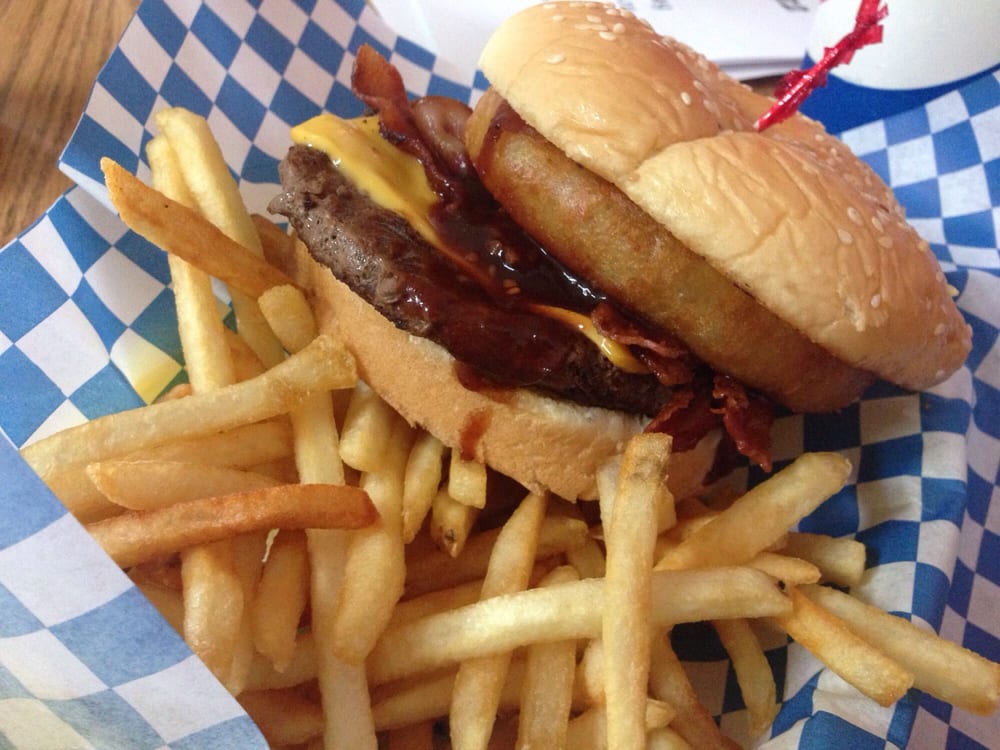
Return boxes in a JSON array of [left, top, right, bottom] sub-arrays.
[[0, 0, 139, 245]]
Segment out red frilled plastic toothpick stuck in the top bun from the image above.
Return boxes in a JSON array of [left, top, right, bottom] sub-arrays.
[[754, 0, 889, 132]]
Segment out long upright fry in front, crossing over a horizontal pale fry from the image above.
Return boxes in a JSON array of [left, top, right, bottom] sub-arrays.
[[601, 433, 673, 750]]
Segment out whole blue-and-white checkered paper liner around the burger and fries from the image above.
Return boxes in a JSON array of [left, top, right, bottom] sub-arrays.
[[0, 0, 1000, 749]]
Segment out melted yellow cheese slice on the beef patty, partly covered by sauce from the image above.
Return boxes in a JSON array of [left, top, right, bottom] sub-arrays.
[[291, 113, 649, 374]]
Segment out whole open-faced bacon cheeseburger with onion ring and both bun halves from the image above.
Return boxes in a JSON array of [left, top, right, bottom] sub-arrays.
[[270, 2, 970, 506]]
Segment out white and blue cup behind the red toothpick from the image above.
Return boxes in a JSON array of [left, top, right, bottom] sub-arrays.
[[801, 0, 1000, 132]]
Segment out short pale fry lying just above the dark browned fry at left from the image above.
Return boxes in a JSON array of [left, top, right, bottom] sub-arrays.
[[87, 459, 279, 510]]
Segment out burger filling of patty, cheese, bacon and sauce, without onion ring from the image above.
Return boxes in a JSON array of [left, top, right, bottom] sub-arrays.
[[271, 42, 788, 469]]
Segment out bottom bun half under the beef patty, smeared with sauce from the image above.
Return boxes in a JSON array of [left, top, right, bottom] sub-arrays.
[[269, 232, 719, 500]]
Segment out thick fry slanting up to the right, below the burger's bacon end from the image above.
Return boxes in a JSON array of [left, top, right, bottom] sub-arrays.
[[656, 453, 851, 570]]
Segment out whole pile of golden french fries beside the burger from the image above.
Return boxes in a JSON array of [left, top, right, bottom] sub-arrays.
[[22, 108, 1000, 750]]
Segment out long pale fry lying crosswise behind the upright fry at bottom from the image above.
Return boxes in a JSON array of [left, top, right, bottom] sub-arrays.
[[368, 568, 791, 684]]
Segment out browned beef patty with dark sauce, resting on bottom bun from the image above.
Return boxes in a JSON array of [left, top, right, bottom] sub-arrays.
[[269, 145, 669, 415]]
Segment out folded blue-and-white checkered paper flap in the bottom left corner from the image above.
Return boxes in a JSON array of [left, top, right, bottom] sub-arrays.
[[0, 437, 266, 750]]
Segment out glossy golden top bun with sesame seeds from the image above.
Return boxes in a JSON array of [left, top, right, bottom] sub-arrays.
[[480, 2, 971, 389]]
